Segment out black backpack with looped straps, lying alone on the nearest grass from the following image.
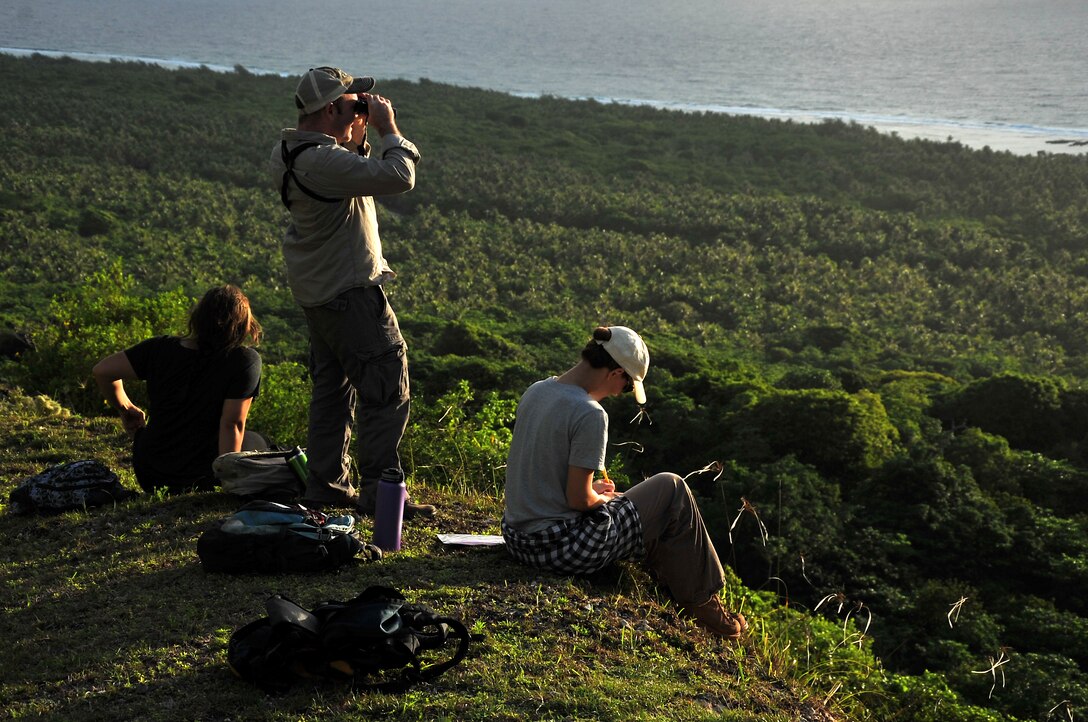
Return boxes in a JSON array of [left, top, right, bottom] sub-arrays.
[[226, 586, 469, 694]]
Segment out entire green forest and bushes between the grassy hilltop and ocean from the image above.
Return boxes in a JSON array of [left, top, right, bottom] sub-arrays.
[[0, 57, 1088, 720]]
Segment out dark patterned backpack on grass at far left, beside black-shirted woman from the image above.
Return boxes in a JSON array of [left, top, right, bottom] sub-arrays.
[[8, 459, 139, 514]]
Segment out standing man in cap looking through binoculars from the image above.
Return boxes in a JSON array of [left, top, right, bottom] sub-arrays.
[[269, 66, 435, 519]]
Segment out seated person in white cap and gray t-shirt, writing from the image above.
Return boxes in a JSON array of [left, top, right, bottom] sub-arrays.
[[502, 326, 747, 639]]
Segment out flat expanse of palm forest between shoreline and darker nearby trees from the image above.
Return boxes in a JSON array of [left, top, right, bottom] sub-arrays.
[[6, 58, 1088, 376]]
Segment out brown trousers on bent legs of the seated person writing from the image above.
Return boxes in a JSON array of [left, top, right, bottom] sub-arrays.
[[623, 473, 725, 608]]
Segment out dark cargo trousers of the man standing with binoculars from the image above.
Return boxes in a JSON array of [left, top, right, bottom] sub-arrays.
[[304, 286, 409, 508]]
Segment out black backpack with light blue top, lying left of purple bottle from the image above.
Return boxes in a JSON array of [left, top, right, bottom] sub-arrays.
[[197, 501, 382, 574]]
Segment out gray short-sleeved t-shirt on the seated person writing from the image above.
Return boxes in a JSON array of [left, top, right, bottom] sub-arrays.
[[504, 376, 608, 534]]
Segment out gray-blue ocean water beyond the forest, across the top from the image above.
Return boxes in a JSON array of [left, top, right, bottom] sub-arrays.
[[0, 0, 1088, 153]]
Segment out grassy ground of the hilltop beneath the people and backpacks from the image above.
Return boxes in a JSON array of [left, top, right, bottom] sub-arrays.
[[0, 388, 857, 722]]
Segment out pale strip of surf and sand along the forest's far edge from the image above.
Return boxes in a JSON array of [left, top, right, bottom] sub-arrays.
[[8, 48, 1088, 155]]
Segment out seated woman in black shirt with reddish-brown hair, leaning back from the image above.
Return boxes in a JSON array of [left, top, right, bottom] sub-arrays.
[[91, 286, 261, 493]]
